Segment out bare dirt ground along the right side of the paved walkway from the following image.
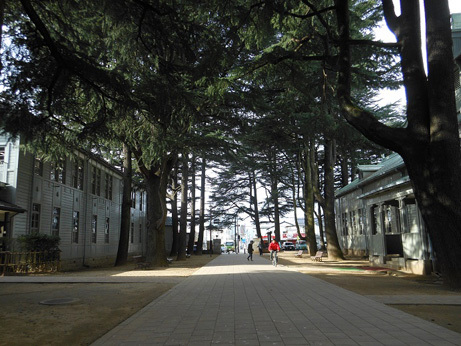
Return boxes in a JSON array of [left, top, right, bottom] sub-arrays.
[[274, 251, 461, 333]]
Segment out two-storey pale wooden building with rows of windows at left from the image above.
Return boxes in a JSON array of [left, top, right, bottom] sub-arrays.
[[0, 135, 146, 269]]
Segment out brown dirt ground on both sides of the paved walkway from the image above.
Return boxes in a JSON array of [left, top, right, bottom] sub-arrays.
[[0, 252, 461, 346]]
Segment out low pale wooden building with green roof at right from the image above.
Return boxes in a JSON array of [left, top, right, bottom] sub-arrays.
[[335, 154, 433, 274]]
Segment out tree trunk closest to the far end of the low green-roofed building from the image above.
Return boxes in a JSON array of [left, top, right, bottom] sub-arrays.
[[324, 139, 344, 260]]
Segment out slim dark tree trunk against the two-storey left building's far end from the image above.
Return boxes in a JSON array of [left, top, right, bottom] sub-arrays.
[[115, 144, 133, 266]]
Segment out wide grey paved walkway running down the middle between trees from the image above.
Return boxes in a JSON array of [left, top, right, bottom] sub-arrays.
[[93, 254, 461, 346]]
